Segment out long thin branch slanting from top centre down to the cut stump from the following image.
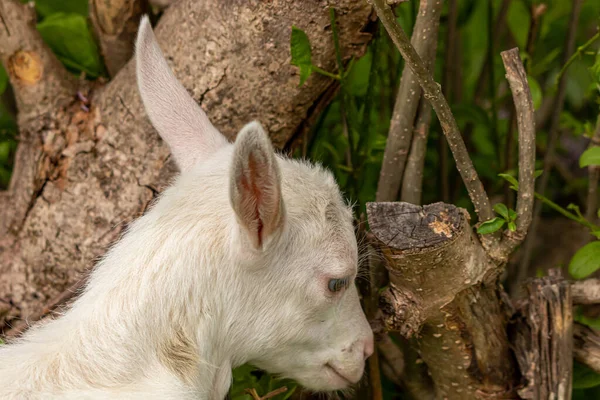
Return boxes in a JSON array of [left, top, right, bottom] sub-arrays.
[[372, 0, 493, 221]]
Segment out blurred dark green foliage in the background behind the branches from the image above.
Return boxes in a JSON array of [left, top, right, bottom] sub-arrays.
[[0, 0, 600, 399]]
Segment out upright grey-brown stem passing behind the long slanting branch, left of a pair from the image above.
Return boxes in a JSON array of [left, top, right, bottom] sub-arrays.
[[375, 0, 443, 201]]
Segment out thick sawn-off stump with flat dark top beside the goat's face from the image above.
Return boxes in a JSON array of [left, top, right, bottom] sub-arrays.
[[367, 203, 517, 399]]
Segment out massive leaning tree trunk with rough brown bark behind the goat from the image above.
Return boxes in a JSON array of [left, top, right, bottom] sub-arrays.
[[0, 0, 371, 332]]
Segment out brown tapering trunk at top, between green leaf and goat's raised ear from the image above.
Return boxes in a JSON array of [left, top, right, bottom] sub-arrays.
[[89, 0, 148, 76]]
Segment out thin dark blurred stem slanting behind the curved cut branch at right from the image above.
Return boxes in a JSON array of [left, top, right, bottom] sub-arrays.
[[513, 0, 583, 289]]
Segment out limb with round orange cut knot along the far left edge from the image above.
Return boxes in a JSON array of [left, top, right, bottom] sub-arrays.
[[0, 0, 76, 245]]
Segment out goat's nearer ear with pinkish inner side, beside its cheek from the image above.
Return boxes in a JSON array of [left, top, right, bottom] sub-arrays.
[[229, 122, 284, 249]]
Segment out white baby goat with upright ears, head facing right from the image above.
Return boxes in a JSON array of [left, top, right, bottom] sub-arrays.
[[0, 18, 373, 400]]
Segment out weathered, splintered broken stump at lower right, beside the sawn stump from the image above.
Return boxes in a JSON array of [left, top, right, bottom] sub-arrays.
[[511, 272, 573, 400]]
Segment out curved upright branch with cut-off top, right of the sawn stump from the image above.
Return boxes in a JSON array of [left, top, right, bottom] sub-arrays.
[[500, 48, 535, 257]]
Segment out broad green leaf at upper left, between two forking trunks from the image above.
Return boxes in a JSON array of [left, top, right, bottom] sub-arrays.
[[37, 13, 104, 77]]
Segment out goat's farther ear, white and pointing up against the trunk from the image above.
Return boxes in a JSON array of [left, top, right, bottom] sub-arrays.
[[135, 16, 227, 171]]
